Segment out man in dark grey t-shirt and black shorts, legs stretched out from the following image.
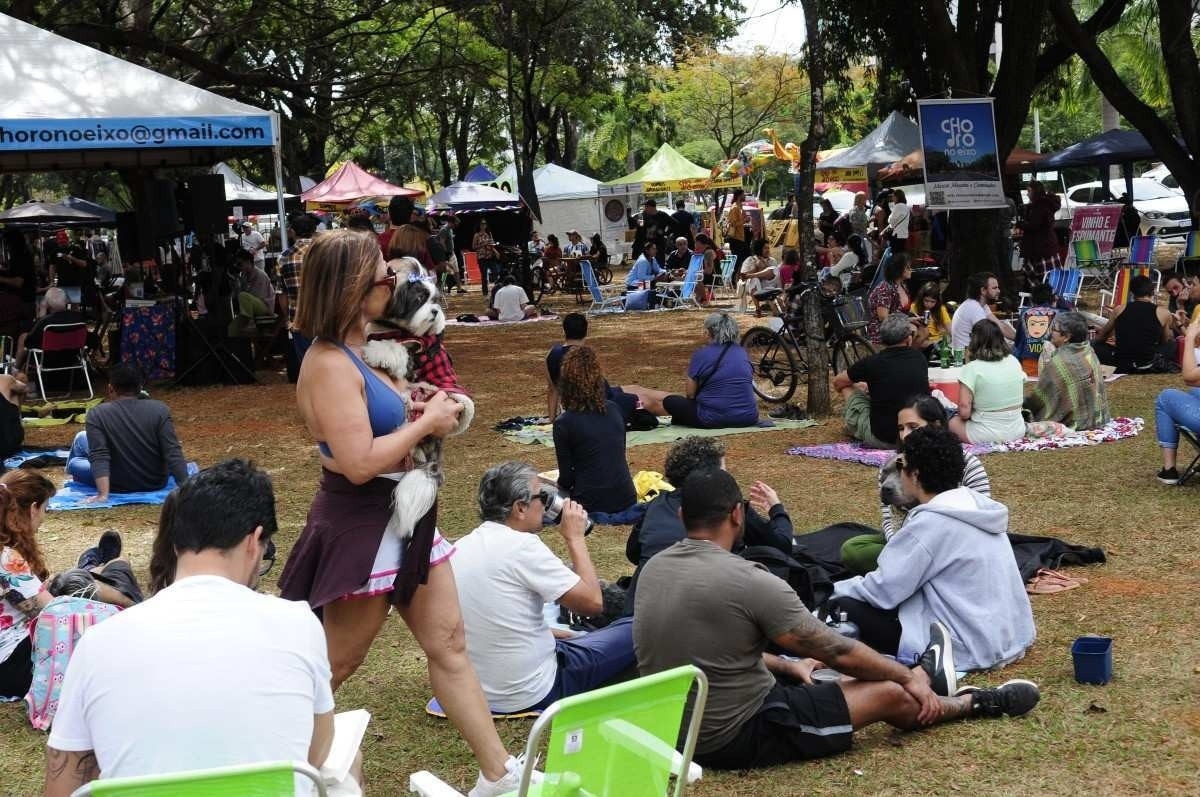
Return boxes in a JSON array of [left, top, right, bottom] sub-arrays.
[[634, 471, 1039, 769]]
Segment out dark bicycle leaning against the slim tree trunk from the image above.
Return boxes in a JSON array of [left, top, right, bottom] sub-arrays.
[[742, 283, 875, 403]]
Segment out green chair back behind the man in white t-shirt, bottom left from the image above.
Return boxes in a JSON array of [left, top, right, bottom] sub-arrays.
[[71, 761, 326, 797]]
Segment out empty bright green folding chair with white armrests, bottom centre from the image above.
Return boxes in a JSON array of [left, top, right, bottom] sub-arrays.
[[408, 665, 708, 797]]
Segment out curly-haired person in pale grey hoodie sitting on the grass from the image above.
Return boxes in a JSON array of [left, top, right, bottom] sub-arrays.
[[830, 426, 1037, 671]]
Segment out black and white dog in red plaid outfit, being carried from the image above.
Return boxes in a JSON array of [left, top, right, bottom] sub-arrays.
[[362, 257, 475, 539]]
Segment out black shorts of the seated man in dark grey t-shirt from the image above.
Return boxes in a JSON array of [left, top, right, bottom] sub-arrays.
[[695, 683, 854, 769]]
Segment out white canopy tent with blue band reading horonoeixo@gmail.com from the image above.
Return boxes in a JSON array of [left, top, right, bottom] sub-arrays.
[[0, 14, 287, 246]]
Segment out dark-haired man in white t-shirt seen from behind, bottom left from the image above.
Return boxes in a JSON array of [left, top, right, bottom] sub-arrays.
[[46, 460, 343, 797]]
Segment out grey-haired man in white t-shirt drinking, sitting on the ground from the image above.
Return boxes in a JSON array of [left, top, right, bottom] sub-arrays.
[[454, 462, 635, 713]]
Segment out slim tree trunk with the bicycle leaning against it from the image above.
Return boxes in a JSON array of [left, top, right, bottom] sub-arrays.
[[796, 0, 833, 418]]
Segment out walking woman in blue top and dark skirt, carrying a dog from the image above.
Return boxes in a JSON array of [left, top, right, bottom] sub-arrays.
[[280, 230, 530, 795]]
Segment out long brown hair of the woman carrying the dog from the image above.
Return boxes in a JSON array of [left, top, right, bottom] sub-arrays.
[[294, 229, 380, 343]]
